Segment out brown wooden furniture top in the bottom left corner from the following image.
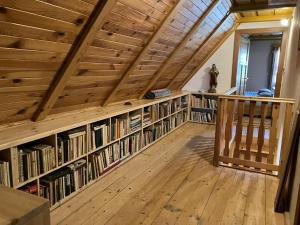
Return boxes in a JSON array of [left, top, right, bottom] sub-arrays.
[[0, 185, 50, 225]]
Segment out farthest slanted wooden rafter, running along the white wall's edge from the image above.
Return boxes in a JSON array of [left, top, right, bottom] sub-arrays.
[[178, 22, 240, 89]]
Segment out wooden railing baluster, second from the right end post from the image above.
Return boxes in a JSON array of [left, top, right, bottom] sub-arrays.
[[256, 102, 268, 162]]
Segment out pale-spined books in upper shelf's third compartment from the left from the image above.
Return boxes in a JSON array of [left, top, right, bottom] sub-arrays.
[[57, 127, 87, 165]]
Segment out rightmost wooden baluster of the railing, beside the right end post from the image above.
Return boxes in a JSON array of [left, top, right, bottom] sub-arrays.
[[268, 103, 280, 164]]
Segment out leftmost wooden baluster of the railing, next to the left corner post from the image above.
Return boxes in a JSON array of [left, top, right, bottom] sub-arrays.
[[224, 100, 234, 156]]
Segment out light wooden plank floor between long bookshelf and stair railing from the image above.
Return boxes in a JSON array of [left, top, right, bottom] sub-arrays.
[[51, 123, 284, 225]]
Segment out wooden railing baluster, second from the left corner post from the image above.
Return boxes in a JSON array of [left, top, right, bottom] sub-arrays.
[[233, 100, 245, 158]]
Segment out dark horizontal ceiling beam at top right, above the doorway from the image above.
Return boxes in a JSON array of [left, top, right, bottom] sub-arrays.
[[231, 3, 296, 13]]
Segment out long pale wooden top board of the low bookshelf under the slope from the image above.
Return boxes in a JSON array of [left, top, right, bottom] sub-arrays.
[[0, 92, 189, 150]]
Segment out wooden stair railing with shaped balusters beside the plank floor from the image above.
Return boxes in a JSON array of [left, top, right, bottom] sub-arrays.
[[214, 95, 294, 175]]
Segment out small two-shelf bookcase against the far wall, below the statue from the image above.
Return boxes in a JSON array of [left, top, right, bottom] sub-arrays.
[[190, 93, 218, 125]]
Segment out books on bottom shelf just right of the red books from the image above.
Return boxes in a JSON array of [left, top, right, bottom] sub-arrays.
[[40, 159, 87, 206]]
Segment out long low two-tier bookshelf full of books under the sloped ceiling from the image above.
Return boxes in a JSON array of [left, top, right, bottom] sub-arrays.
[[0, 93, 189, 210]]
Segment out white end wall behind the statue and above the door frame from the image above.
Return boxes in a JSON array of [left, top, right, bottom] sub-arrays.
[[183, 21, 288, 93]]
